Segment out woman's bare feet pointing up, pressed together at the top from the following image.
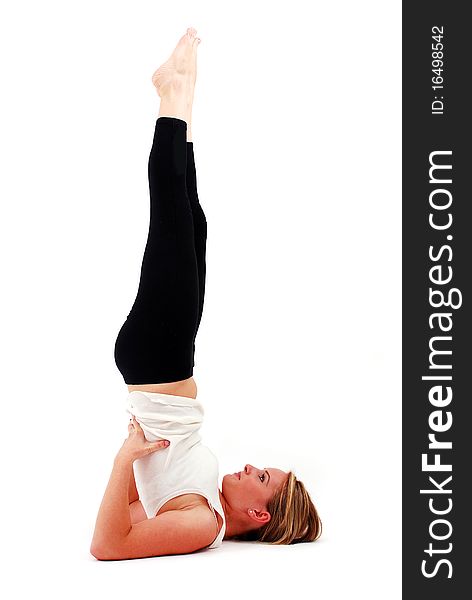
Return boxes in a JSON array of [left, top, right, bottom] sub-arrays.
[[152, 27, 201, 98]]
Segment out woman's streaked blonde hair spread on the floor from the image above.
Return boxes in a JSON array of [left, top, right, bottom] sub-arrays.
[[234, 471, 322, 544]]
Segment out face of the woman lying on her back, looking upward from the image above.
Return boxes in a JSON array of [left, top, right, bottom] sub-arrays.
[[221, 464, 288, 512]]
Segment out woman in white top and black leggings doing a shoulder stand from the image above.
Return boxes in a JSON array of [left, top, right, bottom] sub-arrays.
[[90, 28, 321, 560]]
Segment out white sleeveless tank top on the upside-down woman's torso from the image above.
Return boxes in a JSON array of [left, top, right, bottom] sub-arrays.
[[126, 391, 226, 548]]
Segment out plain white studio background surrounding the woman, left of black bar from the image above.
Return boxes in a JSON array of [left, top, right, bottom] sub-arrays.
[[0, 0, 401, 600]]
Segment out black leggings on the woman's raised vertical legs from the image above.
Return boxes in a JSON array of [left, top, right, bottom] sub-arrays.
[[115, 117, 207, 385]]
